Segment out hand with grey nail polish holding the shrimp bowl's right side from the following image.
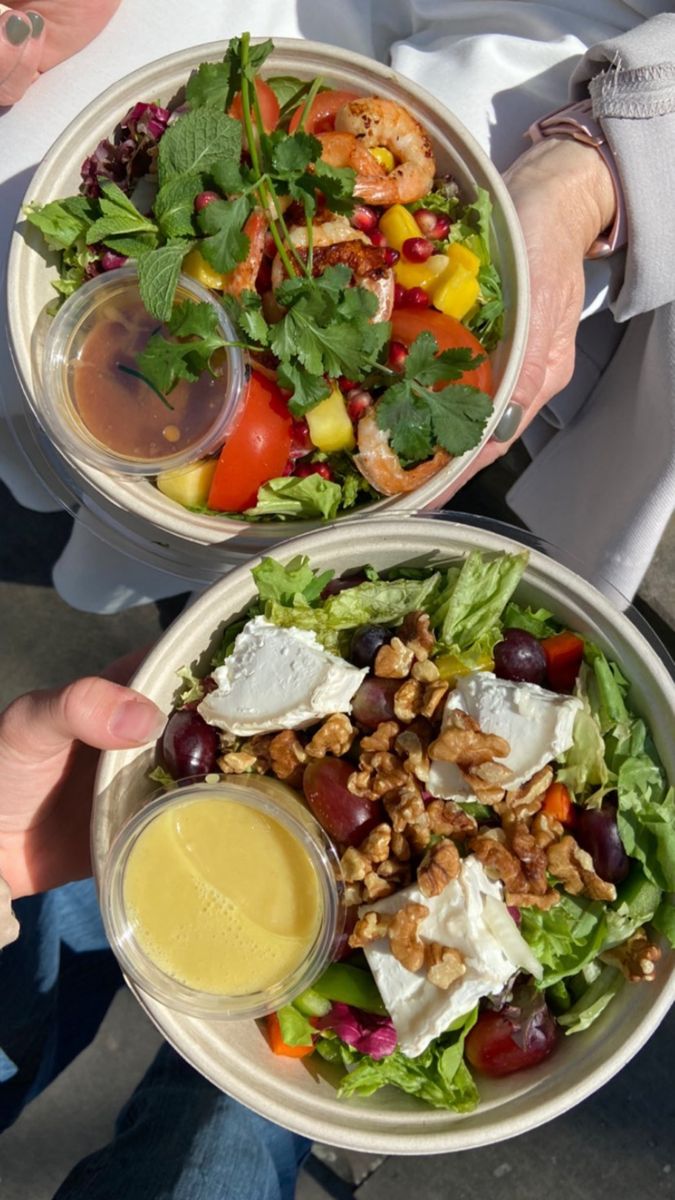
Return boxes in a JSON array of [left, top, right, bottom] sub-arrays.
[[446, 138, 616, 485]]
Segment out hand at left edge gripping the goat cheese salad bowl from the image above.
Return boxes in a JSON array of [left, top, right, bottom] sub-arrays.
[[0, 655, 166, 899]]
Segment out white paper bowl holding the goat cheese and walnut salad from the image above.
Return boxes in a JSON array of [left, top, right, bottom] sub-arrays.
[[92, 517, 675, 1154]]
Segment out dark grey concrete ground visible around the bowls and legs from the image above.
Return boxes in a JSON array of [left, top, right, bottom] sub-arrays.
[[0, 474, 675, 1200]]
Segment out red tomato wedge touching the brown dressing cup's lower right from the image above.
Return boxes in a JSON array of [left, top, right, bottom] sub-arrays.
[[208, 371, 293, 512]]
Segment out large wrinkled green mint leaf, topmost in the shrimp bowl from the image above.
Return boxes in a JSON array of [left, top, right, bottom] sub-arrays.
[[157, 106, 241, 184]]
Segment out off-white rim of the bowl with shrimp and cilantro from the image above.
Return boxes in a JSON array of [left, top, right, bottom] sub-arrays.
[[6, 37, 530, 552]]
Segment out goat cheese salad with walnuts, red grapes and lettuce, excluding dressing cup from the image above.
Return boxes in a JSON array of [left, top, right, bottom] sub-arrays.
[[153, 551, 675, 1112]]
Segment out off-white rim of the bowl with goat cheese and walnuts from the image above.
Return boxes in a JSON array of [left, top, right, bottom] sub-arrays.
[[92, 516, 675, 1154]]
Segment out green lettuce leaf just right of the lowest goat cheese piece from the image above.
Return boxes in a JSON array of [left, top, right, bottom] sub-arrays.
[[520, 892, 607, 989]]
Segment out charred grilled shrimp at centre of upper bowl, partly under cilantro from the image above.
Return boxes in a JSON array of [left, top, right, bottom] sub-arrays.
[[271, 217, 394, 322]]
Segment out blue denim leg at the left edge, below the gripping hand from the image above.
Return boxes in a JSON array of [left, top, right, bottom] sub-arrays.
[[0, 880, 123, 1130]]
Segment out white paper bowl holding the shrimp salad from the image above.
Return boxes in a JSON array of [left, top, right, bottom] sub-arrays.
[[7, 38, 528, 580]]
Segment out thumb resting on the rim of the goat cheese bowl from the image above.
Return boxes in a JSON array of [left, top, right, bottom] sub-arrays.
[[0, 677, 166, 763]]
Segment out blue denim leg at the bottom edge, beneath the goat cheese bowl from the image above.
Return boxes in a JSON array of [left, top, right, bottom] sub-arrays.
[[54, 1044, 310, 1200]]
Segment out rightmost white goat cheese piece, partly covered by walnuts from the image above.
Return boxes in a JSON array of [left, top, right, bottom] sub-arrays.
[[428, 671, 583, 802]]
